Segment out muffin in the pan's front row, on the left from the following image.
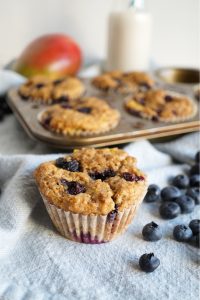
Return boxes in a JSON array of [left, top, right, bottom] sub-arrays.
[[40, 97, 120, 136]]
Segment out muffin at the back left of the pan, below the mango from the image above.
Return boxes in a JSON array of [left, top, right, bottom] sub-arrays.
[[19, 76, 85, 104]]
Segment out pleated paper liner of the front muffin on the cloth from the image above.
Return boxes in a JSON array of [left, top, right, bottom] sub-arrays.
[[41, 191, 146, 244]]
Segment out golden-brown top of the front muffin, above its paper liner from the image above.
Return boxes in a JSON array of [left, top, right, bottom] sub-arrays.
[[35, 148, 147, 215]]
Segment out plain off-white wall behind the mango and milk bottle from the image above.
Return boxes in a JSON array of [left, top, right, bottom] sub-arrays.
[[0, 0, 200, 67]]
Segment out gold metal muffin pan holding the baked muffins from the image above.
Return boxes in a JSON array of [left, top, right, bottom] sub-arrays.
[[8, 79, 200, 149]]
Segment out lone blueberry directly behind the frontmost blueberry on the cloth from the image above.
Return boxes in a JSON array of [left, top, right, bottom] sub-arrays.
[[142, 222, 162, 242]]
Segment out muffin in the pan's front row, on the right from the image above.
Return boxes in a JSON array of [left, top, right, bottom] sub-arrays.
[[125, 89, 197, 122]]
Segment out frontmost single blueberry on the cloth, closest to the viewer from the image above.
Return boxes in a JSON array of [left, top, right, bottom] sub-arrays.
[[139, 253, 160, 273]]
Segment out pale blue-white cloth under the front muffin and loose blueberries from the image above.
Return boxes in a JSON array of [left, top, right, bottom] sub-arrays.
[[0, 134, 200, 300]]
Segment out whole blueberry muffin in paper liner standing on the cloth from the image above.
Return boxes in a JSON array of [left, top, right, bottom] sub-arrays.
[[35, 148, 147, 243]]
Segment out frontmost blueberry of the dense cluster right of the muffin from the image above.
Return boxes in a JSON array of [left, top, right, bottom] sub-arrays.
[[160, 201, 181, 219]]
